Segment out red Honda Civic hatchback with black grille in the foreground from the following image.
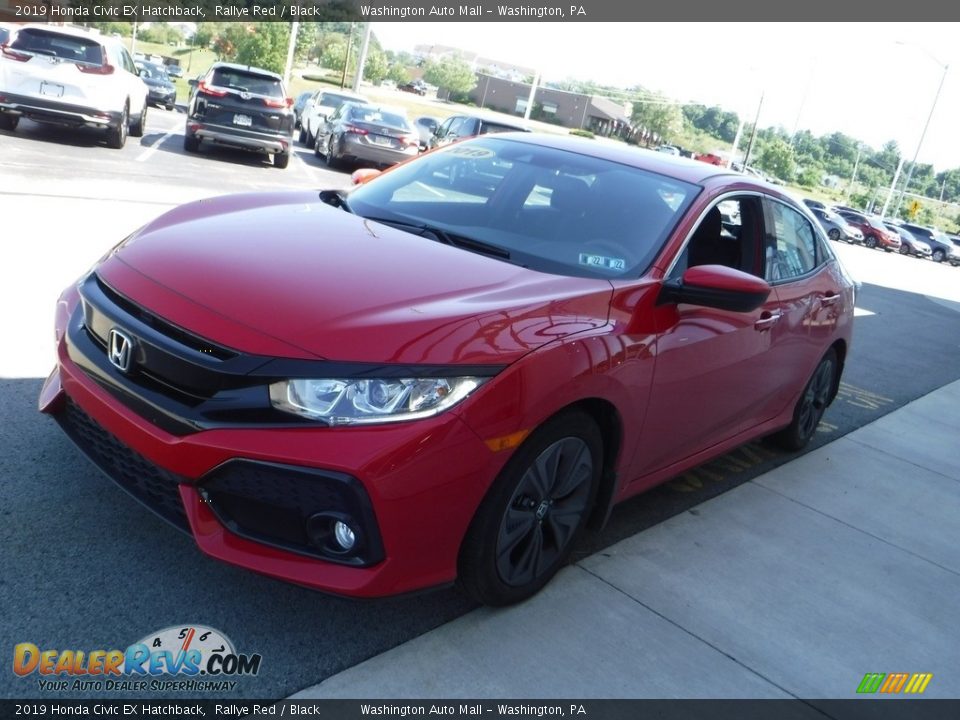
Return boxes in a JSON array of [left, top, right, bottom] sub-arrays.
[[40, 133, 855, 604]]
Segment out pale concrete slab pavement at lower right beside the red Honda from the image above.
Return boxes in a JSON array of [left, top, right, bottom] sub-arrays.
[[294, 381, 960, 699]]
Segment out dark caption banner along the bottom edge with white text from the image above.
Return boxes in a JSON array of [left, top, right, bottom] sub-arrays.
[[0, 698, 960, 720]]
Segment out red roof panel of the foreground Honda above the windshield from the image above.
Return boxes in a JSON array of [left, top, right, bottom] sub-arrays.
[[488, 133, 752, 188]]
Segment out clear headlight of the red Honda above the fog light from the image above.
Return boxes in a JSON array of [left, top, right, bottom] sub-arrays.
[[270, 377, 489, 425]]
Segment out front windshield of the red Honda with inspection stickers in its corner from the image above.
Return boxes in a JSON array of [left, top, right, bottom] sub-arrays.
[[349, 136, 700, 278]]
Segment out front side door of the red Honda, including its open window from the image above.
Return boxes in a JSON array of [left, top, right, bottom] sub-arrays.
[[631, 194, 784, 477]]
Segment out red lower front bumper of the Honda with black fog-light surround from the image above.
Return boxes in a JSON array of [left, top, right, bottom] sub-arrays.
[[40, 286, 505, 597]]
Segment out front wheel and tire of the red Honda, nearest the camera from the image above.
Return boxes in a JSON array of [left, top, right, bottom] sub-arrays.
[[458, 411, 603, 606]]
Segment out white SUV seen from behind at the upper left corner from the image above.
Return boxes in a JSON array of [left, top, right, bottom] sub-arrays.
[[0, 25, 148, 148]]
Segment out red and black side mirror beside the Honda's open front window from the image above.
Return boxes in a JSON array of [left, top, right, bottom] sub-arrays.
[[657, 265, 771, 313]]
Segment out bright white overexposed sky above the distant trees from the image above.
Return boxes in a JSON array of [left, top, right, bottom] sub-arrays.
[[373, 22, 960, 172]]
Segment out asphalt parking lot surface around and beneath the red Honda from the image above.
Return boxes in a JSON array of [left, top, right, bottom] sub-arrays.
[[0, 109, 960, 697]]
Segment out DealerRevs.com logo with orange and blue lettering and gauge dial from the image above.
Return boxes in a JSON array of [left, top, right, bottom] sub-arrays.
[[13, 625, 262, 692]]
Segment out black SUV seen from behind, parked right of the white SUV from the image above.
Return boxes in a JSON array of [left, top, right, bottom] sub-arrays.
[[183, 63, 295, 168]]
